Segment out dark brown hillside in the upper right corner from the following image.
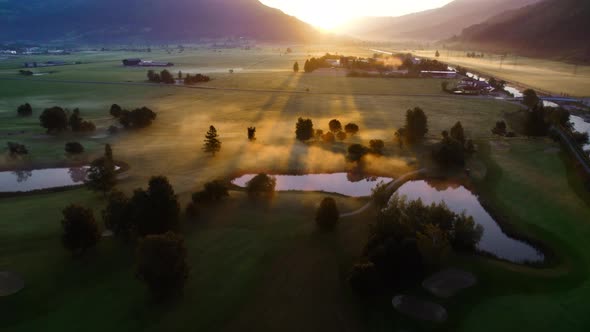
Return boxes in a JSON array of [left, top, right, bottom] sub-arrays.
[[451, 0, 590, 62]]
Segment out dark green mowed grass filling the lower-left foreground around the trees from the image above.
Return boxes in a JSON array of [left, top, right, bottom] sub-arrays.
[[0, 190, 366, 331]]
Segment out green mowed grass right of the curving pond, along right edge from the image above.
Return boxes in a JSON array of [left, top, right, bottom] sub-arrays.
[[455, 141, 590, 331]]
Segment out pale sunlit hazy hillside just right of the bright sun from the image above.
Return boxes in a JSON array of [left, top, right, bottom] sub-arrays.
[[342, 0, 538, 41]]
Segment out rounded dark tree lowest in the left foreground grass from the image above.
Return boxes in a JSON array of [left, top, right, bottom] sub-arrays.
[[136, 232, 189, 301]]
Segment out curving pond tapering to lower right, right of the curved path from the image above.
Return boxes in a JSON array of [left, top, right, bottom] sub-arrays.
[[397, 181, 544, 263]]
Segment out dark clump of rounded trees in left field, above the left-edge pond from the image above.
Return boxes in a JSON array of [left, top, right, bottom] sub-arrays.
[[39, 106, 96, 133]]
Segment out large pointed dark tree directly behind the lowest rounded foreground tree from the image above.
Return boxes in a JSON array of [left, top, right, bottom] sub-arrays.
[[131, 176, 180, 236]]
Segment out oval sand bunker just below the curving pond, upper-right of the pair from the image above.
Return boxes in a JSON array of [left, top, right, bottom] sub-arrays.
[[422, 269, 477, 298]]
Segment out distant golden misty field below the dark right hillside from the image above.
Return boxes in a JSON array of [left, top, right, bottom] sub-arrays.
[[413, 50, 590, 97]]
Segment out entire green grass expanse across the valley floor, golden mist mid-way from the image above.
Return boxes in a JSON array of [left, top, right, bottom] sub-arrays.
[[0, 46, 590, 332]]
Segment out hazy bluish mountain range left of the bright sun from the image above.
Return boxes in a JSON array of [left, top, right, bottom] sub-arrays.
[[0, 0, 317, 43]]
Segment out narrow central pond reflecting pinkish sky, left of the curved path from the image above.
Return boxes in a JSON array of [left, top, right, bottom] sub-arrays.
[[232, 173, 393, 197]]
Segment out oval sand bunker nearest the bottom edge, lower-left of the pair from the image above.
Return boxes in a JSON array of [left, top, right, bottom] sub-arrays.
[[391, 295, 447, 323]]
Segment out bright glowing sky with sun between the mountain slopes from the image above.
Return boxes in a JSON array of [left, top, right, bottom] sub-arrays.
[[260, 0, 452, 29]]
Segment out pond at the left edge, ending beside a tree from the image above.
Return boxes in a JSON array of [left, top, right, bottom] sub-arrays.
[[0, 167, 87, 193]]
